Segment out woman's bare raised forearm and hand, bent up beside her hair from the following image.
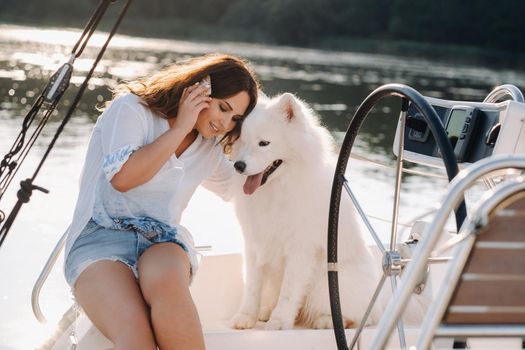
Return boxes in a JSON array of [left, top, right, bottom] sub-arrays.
[[111, 85, 211, 192]]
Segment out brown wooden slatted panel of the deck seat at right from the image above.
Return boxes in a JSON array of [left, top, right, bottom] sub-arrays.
[[443, 191, 525, 325]]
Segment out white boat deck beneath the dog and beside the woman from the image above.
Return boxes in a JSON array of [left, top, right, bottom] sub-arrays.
[[40, 254, 521, 350]]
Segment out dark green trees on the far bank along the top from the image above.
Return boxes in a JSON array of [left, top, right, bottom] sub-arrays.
[[0, 0, 525, 53]]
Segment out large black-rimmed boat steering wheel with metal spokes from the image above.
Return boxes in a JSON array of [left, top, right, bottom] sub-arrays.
[[328, 84, 466, 350]]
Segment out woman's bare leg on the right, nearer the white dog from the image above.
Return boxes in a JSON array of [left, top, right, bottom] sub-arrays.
[[138, 243, 204, 350]]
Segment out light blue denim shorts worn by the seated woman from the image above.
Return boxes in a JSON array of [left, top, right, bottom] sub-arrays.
[[65, 219, 196, 289]]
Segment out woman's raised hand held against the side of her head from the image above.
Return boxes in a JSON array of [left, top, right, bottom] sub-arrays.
[[172, 83, 211, 134]]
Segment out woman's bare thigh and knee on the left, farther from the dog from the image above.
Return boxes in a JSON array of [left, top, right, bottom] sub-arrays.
[[75, 260, 157, 350]]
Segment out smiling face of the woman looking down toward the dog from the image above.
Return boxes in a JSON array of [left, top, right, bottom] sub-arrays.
[[195, 91, 250, 138]]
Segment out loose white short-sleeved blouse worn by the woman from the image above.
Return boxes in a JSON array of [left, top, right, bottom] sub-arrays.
[[64, 94, 234, 273]]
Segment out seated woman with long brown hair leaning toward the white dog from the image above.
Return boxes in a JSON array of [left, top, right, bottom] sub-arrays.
[[65, 55, 258, 350]]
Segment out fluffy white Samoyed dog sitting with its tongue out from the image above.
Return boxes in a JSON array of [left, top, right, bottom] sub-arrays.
[[231, 93, 425, 329]]
